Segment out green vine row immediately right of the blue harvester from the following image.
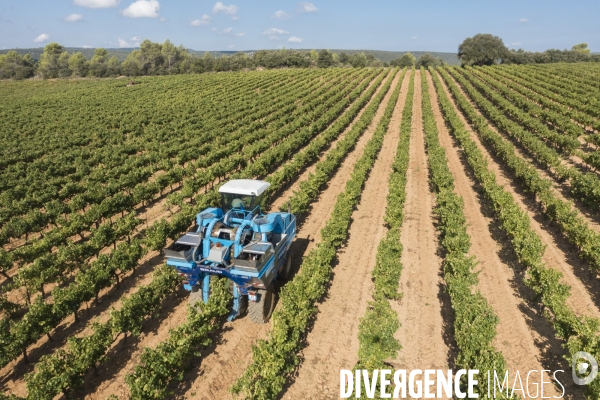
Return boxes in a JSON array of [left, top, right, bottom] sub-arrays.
[[231, 67, 404, 399]]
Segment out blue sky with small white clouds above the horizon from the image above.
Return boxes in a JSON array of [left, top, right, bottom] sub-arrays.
[[0, 0, 600, 52]]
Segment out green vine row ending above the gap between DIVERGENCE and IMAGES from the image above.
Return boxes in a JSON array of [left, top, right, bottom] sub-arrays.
[[421, 69, 506, 398]]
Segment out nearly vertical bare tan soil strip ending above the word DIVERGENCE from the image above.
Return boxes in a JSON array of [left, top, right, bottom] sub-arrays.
[[391, 72, 452, 380]]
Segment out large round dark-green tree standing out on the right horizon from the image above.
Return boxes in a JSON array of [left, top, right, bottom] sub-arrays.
[[458, 33, 508, 65]]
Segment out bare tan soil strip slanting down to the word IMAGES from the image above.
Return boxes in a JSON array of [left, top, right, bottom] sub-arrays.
[[427, 70, 558, 395]]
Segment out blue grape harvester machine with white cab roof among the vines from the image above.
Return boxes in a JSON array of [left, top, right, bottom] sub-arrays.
[[163, 179, 296, 324]]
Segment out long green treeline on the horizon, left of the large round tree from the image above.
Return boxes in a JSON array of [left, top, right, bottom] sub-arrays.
[[0, 40, 444, 79]]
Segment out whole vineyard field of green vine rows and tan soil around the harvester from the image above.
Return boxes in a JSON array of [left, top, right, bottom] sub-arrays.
[[0, 63, 600, 400]]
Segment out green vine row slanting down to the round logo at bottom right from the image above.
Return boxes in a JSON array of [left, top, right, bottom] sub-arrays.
[[432, 68, 600, 399]]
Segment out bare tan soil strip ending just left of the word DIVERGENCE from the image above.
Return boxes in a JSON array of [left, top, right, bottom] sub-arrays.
[[283, 69, 410, 399]]
